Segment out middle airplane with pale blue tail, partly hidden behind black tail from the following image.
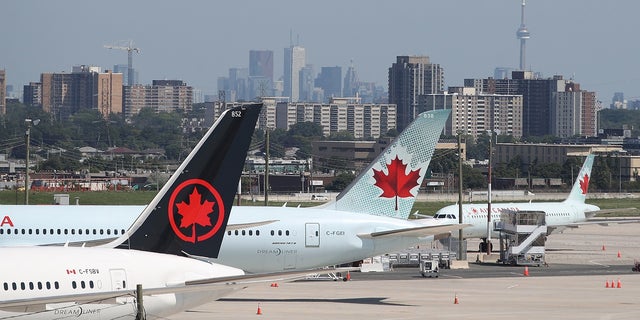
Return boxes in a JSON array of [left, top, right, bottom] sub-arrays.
[[0, 110, 464, 273]]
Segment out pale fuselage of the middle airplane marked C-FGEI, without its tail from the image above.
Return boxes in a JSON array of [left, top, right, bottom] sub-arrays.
[[0, 206, 440, 273]]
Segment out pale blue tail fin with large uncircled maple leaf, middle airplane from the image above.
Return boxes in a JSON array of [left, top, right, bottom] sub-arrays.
[[324, 110, 451, 219]]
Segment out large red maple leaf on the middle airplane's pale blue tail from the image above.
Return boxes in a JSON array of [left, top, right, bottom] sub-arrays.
[[373, 155, 420, 210]]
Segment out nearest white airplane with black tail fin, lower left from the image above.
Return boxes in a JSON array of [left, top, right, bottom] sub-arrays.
[[0, 104, 274, 320]]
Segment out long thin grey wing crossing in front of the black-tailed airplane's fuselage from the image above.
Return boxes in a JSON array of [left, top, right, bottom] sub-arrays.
[[0, 268, 358, 312]]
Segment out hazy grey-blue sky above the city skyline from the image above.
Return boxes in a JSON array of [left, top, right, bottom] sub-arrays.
[[0, 0, 640, 102]]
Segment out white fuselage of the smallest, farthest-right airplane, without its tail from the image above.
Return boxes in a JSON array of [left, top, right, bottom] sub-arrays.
[[434, 201, 599, 238]]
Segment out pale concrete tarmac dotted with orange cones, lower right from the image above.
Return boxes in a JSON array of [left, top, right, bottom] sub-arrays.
[[168, 223, 640, 320]]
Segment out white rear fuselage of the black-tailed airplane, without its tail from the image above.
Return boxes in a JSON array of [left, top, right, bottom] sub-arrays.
[[0, 247, 243, 319]]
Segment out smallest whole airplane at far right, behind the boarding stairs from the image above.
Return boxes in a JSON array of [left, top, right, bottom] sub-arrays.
[[433, 154, 604, 252]]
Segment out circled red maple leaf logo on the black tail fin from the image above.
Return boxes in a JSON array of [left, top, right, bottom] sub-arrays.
[[168, 179, 225, 243]]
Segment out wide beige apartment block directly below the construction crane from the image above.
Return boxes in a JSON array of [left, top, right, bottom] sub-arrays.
[[123, 80, 193, 119]]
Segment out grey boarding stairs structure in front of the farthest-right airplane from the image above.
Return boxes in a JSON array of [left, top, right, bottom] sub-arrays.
[[495, 211, 547, 266]]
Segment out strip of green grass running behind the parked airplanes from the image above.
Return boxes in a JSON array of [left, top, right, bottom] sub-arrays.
[[0, 190, 640, 216]]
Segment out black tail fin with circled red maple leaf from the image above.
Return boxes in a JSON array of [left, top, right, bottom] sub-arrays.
[[120, 104, 262, 258]]
